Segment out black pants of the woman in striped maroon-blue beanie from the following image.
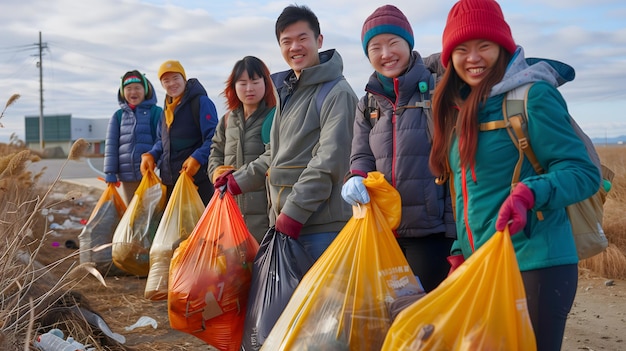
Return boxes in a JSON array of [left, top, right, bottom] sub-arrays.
[[398, 233, 453, 292]]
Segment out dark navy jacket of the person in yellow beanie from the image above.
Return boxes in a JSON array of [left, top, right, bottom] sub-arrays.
[[150, 78, 218, 186]]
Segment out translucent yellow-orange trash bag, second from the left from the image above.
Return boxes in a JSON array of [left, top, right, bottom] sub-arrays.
[[112, 170, 166, 277]]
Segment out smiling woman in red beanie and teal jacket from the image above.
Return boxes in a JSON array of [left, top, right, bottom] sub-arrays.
[[430, 0, 600, 351]]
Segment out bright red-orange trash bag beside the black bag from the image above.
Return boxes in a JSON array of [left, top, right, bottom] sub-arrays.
[[167, 190, 259, 351]]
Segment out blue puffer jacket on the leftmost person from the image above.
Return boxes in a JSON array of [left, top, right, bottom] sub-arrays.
[[104, 81, 163, 182]]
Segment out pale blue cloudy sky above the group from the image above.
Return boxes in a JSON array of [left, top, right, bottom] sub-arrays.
[[0, 0, 626, 142]]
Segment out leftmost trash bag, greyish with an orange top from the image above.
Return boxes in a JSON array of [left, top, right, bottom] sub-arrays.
[[78, 183, 126, 275]]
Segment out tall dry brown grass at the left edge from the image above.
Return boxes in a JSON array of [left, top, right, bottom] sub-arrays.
[[0, 140, 126, 350]]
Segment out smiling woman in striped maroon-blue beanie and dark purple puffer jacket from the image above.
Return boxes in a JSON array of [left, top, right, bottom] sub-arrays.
[[341, 5, 456, 292]]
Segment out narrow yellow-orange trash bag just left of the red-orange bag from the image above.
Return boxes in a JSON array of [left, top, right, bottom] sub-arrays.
[[144, 172, 204, 301]]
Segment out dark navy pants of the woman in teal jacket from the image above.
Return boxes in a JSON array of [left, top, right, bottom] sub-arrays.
[[522, 264, 578, 351]]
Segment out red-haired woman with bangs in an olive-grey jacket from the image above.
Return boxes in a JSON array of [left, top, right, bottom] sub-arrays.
[[208, 56, 276, 243]]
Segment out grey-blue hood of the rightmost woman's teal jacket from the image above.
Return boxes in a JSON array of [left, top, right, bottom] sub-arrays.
[[489, 46, 576, 96]]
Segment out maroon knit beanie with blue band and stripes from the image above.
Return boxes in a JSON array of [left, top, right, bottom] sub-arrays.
[[361, 5, 415, 56]]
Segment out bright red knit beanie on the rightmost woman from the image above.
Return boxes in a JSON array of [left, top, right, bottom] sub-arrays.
[[441, 0, 517, 67]]
